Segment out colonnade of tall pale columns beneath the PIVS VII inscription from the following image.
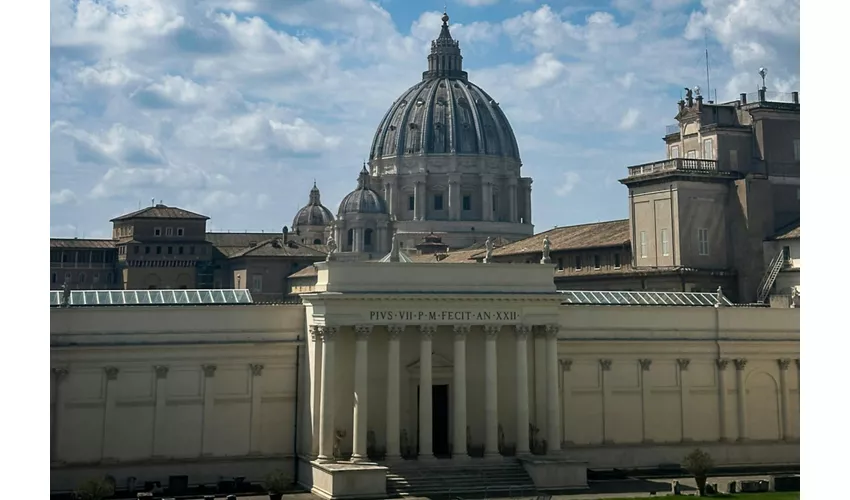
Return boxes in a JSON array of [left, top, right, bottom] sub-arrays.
[[311, 320, 561, 463]]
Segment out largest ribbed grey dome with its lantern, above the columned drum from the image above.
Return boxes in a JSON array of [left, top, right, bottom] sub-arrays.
[[369, 14, 520, 161]]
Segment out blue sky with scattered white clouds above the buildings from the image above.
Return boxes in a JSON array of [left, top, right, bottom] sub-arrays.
[[50, 0, 804, 238]]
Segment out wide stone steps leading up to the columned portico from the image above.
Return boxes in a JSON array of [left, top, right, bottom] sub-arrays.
[[381, 458, 537, 499]]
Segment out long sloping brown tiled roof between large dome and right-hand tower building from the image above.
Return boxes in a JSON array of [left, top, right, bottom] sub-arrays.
[[476, 219, 631, 257]]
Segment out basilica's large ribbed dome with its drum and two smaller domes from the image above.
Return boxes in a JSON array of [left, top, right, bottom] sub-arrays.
[[293, 14, 534, 260]]
